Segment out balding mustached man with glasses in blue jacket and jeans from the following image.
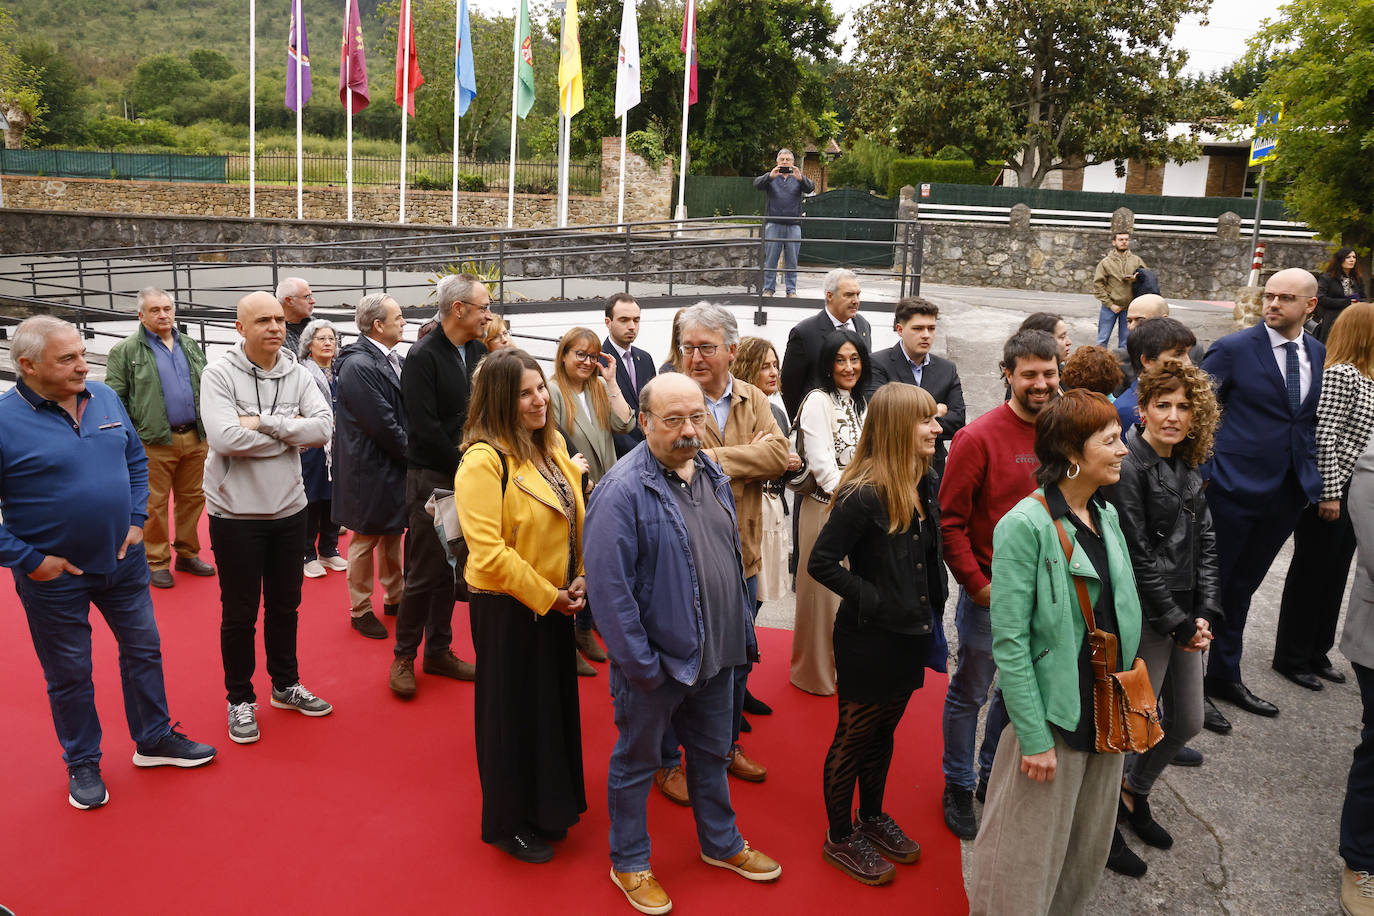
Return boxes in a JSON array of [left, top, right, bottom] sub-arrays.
[[584, 373, 786, 913]]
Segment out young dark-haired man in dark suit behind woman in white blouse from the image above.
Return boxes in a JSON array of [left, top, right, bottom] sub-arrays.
[[868, 295, 965, 475]]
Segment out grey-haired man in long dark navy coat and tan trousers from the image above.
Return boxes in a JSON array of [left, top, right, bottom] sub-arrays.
[[334, 293, 407, 640]]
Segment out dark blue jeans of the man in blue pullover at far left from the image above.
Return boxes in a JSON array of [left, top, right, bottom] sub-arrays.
[[14, 544, 169, 766]]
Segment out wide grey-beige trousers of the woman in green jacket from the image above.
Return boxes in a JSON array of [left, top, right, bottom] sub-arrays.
[[969, 725, 1123, 916]]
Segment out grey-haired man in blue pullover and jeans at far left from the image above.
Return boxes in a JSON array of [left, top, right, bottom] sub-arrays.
[[0, 314, 216, 809]]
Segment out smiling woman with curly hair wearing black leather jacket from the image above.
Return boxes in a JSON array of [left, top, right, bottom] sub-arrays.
[[1107, 360, 1221, 878]]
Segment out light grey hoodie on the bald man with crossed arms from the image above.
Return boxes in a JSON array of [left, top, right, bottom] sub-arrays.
[[201, 341, 334, 519]]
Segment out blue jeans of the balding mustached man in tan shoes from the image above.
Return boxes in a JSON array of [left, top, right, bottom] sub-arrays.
[[606, 662, 745, 872]]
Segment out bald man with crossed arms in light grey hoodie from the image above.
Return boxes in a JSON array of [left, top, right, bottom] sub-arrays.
[[201, 293, 334, 744]]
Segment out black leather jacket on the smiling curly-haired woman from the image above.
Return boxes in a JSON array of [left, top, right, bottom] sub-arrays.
[[1107, 427, 1221, 644]]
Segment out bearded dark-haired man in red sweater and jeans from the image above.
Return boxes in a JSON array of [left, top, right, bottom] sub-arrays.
[[940, 331, 1059, 839]]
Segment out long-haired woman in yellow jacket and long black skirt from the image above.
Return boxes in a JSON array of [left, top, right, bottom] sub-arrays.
[[453, 350, 587, 862]]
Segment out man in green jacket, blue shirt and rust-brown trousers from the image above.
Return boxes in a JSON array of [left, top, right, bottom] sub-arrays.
[[104, 286, 214, 588]]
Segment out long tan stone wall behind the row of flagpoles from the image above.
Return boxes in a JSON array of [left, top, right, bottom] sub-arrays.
[[3, 137, 673, 233]]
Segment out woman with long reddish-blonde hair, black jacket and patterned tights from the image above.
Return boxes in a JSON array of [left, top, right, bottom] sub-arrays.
[[807, 382, 949, 884]]
